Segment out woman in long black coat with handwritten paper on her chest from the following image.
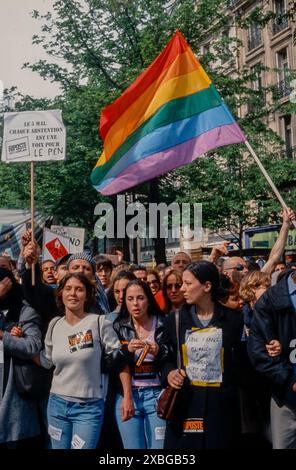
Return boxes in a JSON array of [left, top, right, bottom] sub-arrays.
[[162, 261, 243, 449]]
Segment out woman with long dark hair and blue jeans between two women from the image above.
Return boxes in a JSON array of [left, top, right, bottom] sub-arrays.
[[109, 279, 167, 449]]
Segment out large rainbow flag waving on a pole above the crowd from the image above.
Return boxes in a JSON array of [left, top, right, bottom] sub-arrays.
[[91, 31, 246, 195]]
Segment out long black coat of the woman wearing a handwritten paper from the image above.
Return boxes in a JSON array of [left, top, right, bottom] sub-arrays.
[[162, 304, 243, 449]]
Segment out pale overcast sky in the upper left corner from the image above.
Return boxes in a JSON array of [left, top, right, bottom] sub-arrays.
[[0, 0, 59, 98]]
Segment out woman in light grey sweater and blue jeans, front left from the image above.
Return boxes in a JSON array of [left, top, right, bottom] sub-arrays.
[[33, 273, 120, 449]]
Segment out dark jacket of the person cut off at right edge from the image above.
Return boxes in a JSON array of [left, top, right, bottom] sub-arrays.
[[248, 272, 296, 406]]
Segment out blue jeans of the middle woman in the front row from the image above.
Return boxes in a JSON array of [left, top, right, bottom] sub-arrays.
[[116, 387, 166, 449]]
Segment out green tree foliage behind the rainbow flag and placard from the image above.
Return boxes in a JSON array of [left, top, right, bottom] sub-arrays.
[[0, 0, 295, 248]]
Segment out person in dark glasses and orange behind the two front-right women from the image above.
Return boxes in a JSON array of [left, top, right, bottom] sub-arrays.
[[162, 269, 185, 314]]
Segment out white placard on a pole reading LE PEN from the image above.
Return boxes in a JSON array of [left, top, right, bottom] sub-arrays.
[[1, 109, 66, 163]]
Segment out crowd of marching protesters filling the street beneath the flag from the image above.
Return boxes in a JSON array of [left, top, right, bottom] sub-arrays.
[[0, 210, 296, 449]]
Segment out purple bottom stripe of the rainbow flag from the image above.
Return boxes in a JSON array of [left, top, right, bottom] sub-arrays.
[[96, 123, 247, 196]]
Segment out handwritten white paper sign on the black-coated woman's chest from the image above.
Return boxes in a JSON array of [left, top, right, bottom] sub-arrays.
[[185, 328, 222, 383]]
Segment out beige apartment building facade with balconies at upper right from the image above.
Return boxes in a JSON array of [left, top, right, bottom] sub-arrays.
[[225, 0, 296, 159]]
